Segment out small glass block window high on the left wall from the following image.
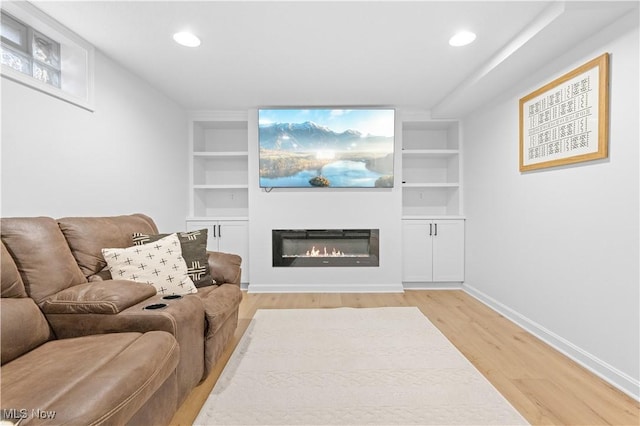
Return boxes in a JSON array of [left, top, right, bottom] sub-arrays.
[[1, 11, 61, 88]]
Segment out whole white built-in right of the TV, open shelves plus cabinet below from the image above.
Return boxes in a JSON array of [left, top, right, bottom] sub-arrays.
[[402, 116, 465, 288]]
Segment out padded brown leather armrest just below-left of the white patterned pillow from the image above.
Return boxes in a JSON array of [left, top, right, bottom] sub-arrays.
[[40, 280, 156, 314]]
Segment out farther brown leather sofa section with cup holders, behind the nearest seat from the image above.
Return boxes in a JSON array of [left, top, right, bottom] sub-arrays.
[[0, 214, 242, 422]]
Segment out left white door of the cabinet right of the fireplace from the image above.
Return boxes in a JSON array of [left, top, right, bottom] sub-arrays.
[[402, 220, 433, 282]]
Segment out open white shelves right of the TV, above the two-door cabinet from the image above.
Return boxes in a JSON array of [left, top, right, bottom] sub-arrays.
[[402, 119, 462, 219]]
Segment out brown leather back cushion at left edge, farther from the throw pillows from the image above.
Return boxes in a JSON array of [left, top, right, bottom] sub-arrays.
[[0, 217, 87, 304]]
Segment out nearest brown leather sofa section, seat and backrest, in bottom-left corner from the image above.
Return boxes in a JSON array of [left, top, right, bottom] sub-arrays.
[[0, 244, 179, 425]]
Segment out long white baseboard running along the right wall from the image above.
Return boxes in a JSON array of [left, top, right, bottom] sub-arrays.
[[462, 284, 640, 401]]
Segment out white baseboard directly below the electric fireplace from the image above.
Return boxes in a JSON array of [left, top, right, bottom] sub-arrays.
[[248, 283, 404, 293]]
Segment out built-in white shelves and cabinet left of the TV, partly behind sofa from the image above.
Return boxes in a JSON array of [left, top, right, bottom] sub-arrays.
[[186, 111, 249, 283]]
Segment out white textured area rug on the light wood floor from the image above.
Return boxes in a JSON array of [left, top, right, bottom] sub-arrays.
[[195, 308, 528, 425]]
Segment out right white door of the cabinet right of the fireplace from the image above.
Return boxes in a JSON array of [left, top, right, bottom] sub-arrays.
[[432, 220, 464, 282]]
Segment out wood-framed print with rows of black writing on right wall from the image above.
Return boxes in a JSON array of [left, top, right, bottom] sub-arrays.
[[519, 53, 609, 172]]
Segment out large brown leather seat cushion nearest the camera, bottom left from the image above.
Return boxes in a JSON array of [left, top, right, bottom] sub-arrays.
[[1, 331, 179, 425]]
